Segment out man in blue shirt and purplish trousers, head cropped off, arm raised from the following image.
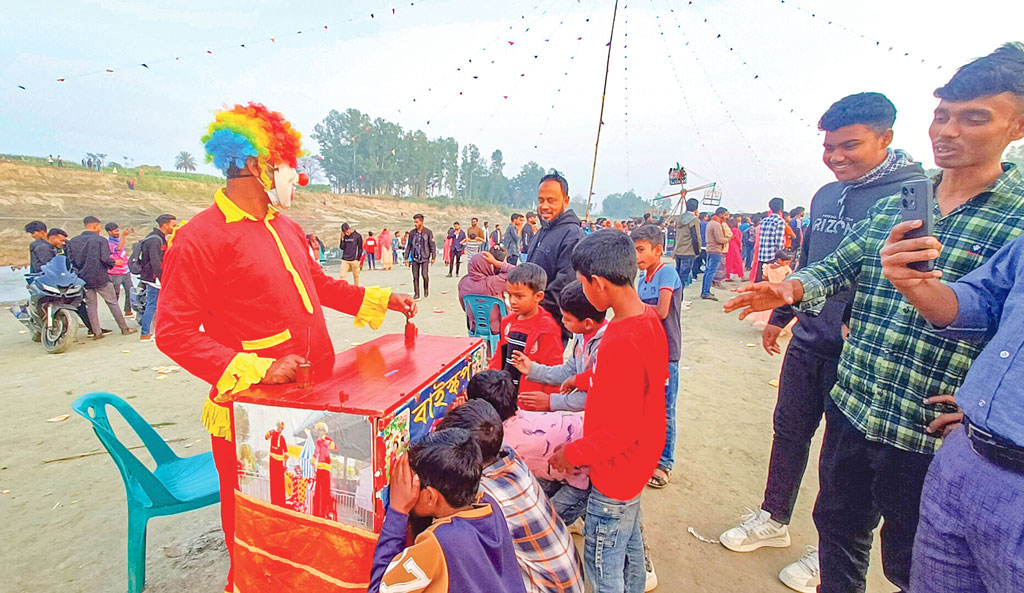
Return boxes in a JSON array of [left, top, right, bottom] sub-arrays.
[[882, 223, 1024, 592]]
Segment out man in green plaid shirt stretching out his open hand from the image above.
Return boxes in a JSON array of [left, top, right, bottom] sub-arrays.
[[725, 44, 1024, 593]]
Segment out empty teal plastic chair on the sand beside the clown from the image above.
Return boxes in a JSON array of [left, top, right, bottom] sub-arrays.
[[71, 393, 220, 593]]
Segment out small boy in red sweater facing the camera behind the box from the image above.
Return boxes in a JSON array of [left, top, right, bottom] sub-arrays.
[[490, 263, 565, 393]]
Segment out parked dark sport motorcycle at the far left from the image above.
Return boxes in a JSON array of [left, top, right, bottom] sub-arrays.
[[11, 255, 85, 354]]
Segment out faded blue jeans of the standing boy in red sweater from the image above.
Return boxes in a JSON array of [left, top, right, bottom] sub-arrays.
[[583, 488, 647, 593]]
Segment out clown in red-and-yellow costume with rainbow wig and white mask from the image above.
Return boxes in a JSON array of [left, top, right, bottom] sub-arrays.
[[156, 103, 416, 591]]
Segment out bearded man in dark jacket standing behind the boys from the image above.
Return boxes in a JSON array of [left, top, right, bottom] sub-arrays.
[[527, 173, 584, 345]]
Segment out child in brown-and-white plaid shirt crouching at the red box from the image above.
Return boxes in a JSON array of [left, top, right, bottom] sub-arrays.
[[437, 399, 584, 593]]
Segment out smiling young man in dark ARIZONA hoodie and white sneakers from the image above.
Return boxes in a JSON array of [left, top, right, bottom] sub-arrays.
[[721, 92, 925, 590]]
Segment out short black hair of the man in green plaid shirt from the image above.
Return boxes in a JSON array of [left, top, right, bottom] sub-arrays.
[[935, 42, 1024, 104]]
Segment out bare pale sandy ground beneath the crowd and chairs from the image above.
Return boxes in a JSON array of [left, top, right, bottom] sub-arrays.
[[0, 264, 893, 593]]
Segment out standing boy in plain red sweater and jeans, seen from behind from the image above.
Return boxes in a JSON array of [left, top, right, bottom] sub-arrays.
[[549, 229, 669, 593]]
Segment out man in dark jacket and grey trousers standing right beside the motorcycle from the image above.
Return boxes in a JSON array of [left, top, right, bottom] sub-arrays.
[[67, 216, 135, 340]]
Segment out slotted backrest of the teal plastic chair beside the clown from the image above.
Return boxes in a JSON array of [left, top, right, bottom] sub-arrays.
[[72, 392, 180, 506]]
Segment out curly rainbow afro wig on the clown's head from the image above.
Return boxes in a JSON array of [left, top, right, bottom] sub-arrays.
[[202, 102, 303, 187]]
